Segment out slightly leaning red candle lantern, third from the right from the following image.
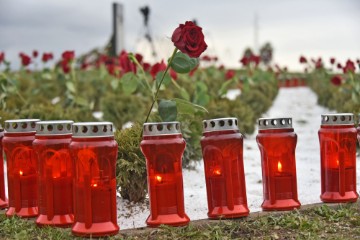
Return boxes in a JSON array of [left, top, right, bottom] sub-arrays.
[[201, 118, 249, 218]]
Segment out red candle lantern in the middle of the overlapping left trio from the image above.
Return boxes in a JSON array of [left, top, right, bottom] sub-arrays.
[[33, 121, 74, 227]]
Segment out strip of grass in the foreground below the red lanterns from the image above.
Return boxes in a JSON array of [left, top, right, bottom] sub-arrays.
[[0, 202, 360, 240]]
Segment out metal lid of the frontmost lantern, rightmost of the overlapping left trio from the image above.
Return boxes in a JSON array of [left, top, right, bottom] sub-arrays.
[[72, 122, 114, 138]]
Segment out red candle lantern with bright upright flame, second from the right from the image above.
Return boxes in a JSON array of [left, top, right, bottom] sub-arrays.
[[256, 118, 300, 210]]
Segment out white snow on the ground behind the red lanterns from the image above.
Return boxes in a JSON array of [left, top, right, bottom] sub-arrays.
[[118, 87, 360, 229]]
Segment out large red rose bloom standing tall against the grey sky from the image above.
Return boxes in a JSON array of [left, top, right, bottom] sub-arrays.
[[171, 21, 207, 58]]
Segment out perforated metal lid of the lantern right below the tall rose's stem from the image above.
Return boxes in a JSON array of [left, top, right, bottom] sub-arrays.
[[143, 122, 181, 136]]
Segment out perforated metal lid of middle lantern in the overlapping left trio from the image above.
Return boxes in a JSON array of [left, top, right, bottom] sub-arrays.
[[36, 120, 74, 135]]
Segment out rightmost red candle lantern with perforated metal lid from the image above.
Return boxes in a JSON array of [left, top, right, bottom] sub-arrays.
[[319, 113, 359, 202]]
